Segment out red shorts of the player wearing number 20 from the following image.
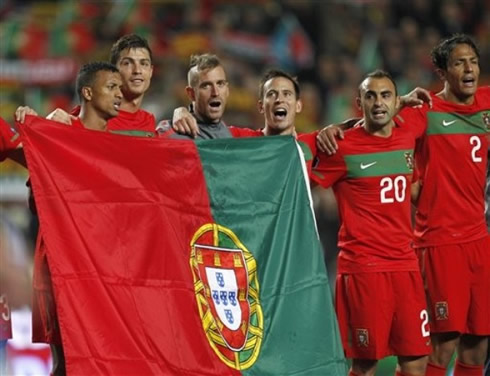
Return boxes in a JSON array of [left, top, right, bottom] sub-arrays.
[[335, 271, 431, 359]]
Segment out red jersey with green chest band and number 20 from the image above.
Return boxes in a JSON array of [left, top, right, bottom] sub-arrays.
[[310, 126, 418, 273]]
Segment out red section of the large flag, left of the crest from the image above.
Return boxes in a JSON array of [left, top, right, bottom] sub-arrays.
[[22, 116, 240, 376]]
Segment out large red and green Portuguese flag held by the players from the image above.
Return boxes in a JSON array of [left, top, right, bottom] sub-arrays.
[[21, 117, 346, 376]]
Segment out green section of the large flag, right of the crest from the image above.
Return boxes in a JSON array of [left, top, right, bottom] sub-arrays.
[[196, 137, 347, 376]]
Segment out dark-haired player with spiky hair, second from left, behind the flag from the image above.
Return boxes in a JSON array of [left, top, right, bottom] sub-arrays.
[[15, 34, 156, 137]]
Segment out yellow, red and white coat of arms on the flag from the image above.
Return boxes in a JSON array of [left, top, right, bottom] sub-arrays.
[[190, 223, 264, 370]]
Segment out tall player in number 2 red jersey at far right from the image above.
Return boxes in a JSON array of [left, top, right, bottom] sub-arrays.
[[400, 35, 490, 376]]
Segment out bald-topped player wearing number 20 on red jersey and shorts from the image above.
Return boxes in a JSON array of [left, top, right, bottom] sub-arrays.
[[309, 70, 430, 376]]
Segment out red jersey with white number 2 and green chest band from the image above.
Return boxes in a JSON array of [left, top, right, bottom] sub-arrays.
[[400, 86, 490, 247]]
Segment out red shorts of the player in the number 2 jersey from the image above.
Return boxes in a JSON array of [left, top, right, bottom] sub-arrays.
[[416, 235, 490, 336]]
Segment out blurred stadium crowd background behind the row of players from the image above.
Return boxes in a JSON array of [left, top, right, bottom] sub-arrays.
[[0, 0, 490, 375]]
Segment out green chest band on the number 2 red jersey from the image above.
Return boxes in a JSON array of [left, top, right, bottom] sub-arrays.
[[427, 111, 488, 135]]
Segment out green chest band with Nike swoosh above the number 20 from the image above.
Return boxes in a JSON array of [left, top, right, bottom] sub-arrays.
[[344, 150, 413, 178]]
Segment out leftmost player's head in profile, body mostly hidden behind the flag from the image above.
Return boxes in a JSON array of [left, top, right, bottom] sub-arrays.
[[28, 62, 123, 375]]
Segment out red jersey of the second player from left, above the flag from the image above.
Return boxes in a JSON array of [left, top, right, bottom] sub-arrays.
[[71, 106, 156, 136]]
